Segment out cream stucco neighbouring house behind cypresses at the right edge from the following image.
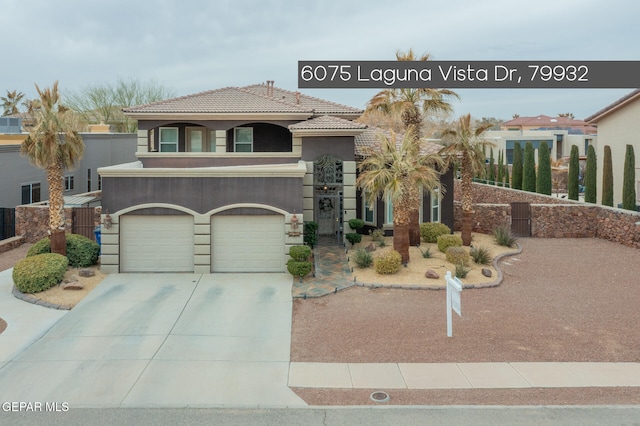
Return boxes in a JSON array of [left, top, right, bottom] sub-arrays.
[[586, 89, 640, 206]]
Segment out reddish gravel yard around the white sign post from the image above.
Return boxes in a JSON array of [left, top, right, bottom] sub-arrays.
[[291, 239, 640, 404]]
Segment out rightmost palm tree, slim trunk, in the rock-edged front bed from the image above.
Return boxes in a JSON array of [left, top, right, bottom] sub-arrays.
[[440, 114, 495, 246]]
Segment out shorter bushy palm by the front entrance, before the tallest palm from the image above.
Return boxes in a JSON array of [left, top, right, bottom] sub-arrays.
[[356, 131, 444, 264]]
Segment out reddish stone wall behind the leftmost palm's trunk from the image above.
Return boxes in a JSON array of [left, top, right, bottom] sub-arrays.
[[16, 204, 102, 243]]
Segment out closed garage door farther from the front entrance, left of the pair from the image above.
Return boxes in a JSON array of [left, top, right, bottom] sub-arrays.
[[120, 215, 193, 272]]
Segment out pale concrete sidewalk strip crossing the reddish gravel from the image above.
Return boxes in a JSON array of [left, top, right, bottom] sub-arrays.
[[289, 362, 640, 389]]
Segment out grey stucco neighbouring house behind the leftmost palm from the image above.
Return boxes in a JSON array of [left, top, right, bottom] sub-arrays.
[[0, 118, 136, 208]]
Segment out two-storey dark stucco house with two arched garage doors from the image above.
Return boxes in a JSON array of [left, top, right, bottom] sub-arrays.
[[99, 81, 453, 273]]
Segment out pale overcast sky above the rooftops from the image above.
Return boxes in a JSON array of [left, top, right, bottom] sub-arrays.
[[0, 0, 640, 119]]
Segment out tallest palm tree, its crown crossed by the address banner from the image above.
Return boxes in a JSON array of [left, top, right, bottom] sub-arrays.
[[365, 49, 459, 245]]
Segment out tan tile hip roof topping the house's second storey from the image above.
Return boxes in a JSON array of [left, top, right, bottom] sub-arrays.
[[124, 84, 362, 118]]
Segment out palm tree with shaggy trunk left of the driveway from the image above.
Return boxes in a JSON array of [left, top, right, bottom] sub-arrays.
[[20, 81, 84, 255]]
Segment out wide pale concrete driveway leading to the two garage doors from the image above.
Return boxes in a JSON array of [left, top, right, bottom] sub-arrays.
[[0, 274, 306, 407]]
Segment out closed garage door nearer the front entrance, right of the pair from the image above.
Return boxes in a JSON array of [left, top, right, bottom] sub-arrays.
[[211, 215, 285, 272]]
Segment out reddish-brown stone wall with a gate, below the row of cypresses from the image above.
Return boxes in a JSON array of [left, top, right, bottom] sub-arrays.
[[454, 182, 640, 248]]
